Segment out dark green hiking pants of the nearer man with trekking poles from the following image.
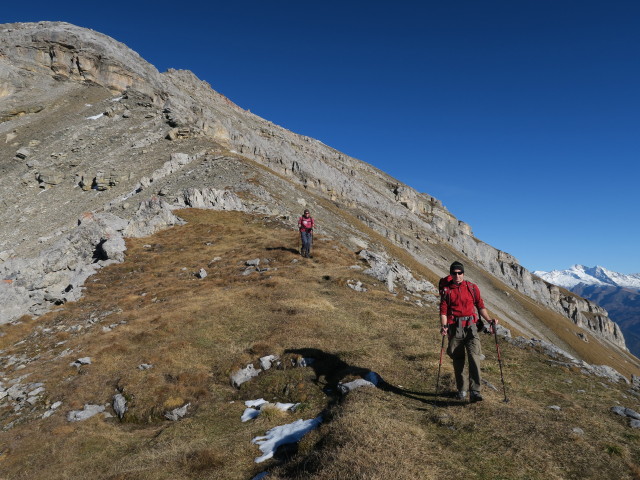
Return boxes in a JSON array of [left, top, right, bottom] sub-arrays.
[[447, 324, 484, 392]]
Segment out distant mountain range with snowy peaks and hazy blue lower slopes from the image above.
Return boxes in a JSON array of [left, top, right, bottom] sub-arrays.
[[533, 265, 640, 357]]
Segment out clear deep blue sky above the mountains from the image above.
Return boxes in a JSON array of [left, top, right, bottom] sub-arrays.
[[5, 0, 640, 273]]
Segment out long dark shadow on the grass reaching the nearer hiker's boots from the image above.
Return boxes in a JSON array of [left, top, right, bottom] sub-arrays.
[[285, 348, 466, 407]]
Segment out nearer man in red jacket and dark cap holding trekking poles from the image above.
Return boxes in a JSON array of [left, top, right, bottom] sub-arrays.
[[440, 262, 498, 402]]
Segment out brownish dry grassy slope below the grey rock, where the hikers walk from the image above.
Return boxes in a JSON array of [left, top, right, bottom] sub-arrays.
[[0, 210, 640, 480]]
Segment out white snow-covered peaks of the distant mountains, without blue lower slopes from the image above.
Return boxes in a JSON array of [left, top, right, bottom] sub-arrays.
[[533, 265, 640, 289]]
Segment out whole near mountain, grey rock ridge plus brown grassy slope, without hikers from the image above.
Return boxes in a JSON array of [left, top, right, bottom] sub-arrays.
[[0, 22, 640, 480]]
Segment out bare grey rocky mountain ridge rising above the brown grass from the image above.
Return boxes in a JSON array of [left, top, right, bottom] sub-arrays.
[[0, 22, 626, 364]]
